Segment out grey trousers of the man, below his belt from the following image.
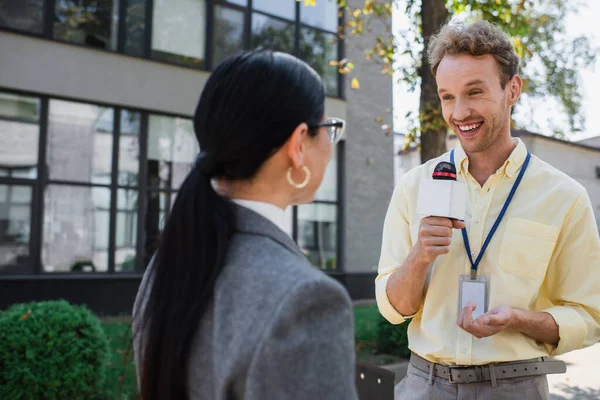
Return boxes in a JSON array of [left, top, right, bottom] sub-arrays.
[[394, 364, 550, 400]]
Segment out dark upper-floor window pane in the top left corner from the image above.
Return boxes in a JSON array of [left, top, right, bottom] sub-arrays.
[[0, 0, 44, 33]]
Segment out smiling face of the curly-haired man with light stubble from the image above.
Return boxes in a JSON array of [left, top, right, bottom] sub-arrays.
[[436, 54, 520, 153]]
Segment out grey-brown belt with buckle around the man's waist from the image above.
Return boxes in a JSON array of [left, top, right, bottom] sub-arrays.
[[410, 353, 567, 386]]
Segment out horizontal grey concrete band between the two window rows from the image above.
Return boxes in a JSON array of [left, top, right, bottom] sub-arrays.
[[0, 32, 346, 118]]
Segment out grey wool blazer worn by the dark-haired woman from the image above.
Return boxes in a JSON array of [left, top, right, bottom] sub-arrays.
[[133, 206, 357, 400]]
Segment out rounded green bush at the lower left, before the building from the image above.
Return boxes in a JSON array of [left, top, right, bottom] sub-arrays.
[[0, 301, 109, 400]]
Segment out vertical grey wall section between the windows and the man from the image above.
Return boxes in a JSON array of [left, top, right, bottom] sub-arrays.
[[343, 0, 394, 273]]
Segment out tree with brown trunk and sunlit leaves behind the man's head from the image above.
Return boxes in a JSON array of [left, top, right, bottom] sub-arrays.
[[318, 0, 595, 162]]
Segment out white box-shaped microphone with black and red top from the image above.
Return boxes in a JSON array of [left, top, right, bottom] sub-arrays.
[[417, 161, 468, 220]]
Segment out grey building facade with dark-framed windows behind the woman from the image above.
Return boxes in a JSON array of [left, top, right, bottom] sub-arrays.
[[0, 0, 393, 314]]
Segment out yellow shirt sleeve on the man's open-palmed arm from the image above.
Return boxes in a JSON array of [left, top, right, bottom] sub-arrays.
[[542, 193, 600, 356]]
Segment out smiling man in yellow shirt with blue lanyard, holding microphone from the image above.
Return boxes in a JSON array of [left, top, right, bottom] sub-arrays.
[[375, 22, 600, 400]]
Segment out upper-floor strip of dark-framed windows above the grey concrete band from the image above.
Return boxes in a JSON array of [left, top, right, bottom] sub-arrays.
[[0, 0, 342, 97]]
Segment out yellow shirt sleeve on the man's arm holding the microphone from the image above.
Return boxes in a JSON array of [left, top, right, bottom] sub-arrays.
[[375, 180, 413, 324]]
